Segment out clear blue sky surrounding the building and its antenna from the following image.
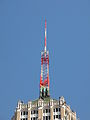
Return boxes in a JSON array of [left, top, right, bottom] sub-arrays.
[[0, 0, 90, 120]]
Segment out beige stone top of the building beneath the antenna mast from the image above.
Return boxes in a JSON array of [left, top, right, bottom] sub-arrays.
[[12, 97, 76, 120]]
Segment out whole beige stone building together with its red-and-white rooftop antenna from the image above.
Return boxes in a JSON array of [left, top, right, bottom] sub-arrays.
[[12, 20, 76, 120]]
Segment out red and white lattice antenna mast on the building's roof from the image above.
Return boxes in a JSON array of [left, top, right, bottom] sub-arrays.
[[40, 20, 50, 98]]
